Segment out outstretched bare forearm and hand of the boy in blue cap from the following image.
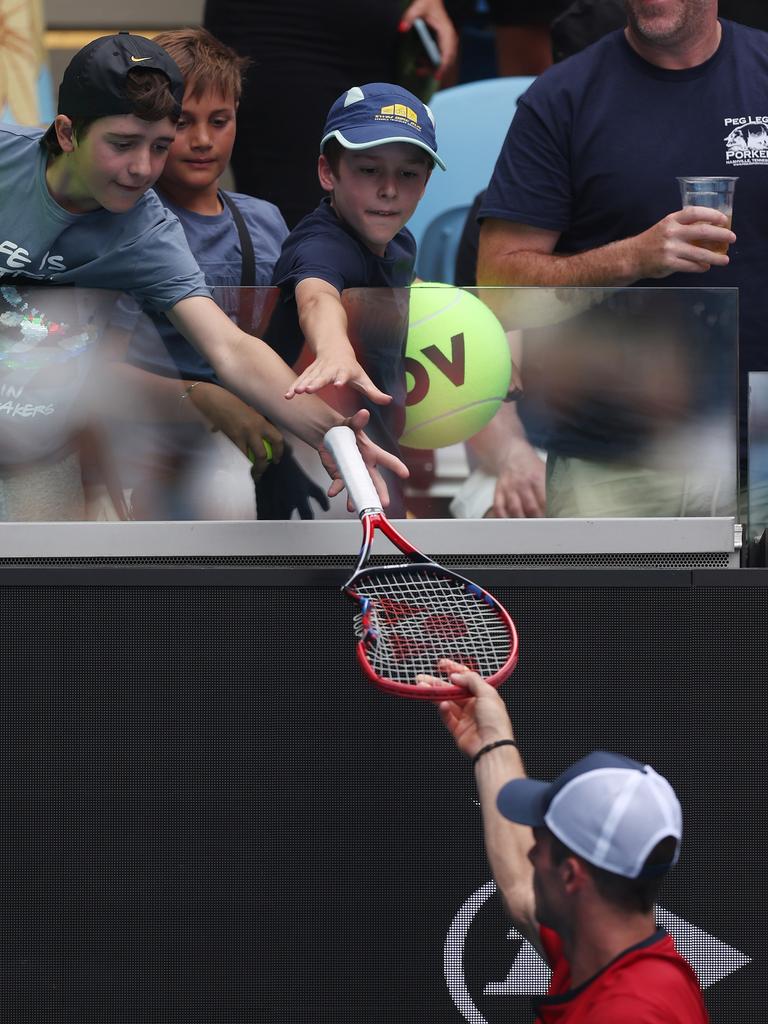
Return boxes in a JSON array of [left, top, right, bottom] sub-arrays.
[[286, 278, 392, 404]]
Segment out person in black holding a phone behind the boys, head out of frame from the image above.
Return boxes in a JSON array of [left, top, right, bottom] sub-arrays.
[[204, 0, 458, 228]]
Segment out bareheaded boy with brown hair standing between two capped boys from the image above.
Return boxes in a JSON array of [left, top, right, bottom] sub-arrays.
[[116, 28, 327, 518]]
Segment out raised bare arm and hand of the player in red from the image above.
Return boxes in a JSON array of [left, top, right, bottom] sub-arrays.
[[422, 660, 540, 948]]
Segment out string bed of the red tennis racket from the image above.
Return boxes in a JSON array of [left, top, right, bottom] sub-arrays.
[[354, 570, 511, 685]]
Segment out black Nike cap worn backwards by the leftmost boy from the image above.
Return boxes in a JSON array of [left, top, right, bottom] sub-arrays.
[[58, 32, 184, 118]]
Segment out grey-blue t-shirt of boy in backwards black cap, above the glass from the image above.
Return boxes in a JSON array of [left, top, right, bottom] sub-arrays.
[[0, 125, 210, 312]]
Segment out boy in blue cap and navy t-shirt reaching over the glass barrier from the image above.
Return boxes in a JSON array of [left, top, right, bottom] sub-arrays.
[[267, 82, 444, 514]]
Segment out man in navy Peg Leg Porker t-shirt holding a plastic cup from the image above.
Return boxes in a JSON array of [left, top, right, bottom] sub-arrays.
[[478, 0, 768, 515]]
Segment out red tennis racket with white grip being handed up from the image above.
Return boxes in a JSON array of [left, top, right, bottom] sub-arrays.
[[325, 419, 517, 700]]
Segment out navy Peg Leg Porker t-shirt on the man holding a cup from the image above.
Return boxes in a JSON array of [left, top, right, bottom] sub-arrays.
[[479, 22, 768, 458]]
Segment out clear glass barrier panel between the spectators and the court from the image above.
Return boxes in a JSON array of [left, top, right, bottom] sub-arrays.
[[0, 285, 741, 522]]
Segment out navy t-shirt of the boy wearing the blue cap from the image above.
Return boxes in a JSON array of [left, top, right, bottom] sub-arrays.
[[266, 193, 416, 462]]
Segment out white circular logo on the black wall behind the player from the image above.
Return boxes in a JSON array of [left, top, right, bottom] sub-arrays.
[[443, 882, 752, 1024]]
